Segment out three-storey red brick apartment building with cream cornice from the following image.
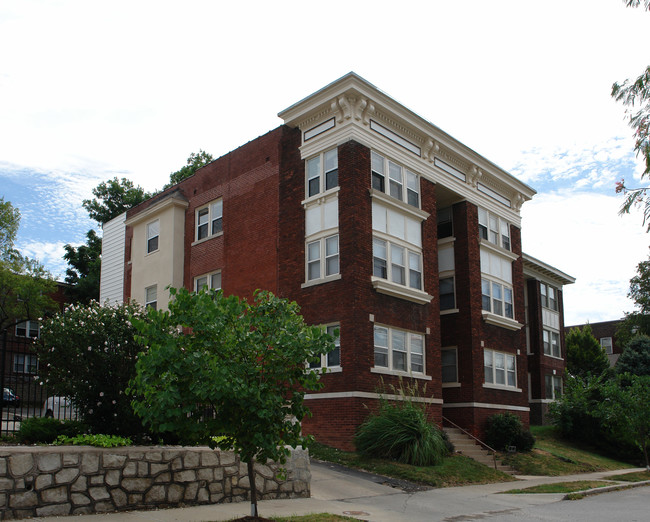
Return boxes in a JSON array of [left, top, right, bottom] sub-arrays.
[[101, 73, 573, 448]]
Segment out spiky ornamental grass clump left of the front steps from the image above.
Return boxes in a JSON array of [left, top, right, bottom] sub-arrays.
[[354, 382, 449, 466]]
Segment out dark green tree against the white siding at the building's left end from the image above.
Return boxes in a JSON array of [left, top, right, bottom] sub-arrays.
[[63, 229, 102, 304]]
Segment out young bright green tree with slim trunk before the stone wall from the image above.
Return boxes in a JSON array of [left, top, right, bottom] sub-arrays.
[[130, 288, 334, 516]]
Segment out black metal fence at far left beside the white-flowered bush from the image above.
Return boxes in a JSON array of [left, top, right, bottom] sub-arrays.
[[0, 334, 77, 435]]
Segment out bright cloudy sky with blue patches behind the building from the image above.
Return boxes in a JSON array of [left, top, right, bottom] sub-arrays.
[[0, 0, 650, 324]]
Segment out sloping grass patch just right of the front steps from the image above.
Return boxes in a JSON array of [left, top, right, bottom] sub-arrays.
[[503, 426, 629, 476]]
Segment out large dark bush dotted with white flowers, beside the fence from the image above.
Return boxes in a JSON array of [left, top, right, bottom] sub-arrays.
[[37, 301, 146, 436]]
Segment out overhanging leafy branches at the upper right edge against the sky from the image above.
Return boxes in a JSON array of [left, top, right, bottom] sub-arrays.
[[612, 0, 650, 231]]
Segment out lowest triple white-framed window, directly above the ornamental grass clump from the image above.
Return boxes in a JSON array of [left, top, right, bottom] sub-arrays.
[[374, 325, 424, 374]]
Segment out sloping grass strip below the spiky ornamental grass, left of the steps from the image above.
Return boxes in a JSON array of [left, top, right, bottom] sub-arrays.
[[309, 443, 513, 488]]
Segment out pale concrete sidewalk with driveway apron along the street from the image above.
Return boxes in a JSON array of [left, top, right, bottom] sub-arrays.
[[32, 462, 645, 522]]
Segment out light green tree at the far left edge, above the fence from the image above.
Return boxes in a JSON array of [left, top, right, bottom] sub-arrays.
[[0, 198, 56, 332]]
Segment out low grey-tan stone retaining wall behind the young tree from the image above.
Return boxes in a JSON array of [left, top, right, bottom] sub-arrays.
[[0, 446, 311, 520]]
